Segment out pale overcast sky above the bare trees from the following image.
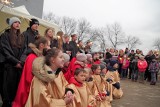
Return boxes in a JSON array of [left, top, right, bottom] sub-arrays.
[[43, 0, 160, 51]]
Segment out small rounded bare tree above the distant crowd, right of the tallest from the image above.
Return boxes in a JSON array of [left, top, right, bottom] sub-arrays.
[[126, 35, 141, 50]]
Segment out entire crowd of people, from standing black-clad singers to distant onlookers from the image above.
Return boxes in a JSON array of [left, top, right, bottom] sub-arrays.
[[0, 17, 160, 107]]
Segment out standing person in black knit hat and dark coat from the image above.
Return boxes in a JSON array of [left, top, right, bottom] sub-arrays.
[[21, 18, 39, 63]]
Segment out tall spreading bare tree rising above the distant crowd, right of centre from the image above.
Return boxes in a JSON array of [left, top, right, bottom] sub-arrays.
[[106, 23, 125, 49]]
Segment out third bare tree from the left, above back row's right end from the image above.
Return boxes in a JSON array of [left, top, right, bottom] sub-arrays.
[[77, 18, 91, 40]]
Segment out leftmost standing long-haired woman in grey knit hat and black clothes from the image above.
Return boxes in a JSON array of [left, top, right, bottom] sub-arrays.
[[0, 17, 24, 107]]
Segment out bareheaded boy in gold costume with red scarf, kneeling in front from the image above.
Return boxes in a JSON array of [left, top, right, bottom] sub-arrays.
[[67, 68, 96, 107]]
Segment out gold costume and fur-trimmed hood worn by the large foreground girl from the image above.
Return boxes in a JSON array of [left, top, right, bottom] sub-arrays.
[[25, 57, 70, 107]]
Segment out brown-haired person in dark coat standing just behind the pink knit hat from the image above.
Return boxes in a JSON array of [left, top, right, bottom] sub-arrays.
[[69, 34, 78, 59]]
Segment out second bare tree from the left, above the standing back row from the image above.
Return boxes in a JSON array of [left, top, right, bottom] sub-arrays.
[[61, 16, 77, 35]]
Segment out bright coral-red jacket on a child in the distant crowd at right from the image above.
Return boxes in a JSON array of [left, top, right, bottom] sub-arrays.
[[138, 60, 148, 72]]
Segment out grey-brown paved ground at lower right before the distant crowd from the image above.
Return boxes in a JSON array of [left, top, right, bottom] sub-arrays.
[[112, 79, 160, 107]]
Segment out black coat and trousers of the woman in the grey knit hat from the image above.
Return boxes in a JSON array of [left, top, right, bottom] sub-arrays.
[[0, 30, 23, 103]]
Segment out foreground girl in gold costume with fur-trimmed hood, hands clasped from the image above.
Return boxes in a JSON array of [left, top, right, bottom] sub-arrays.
[[25, 48, 74, 107]]
